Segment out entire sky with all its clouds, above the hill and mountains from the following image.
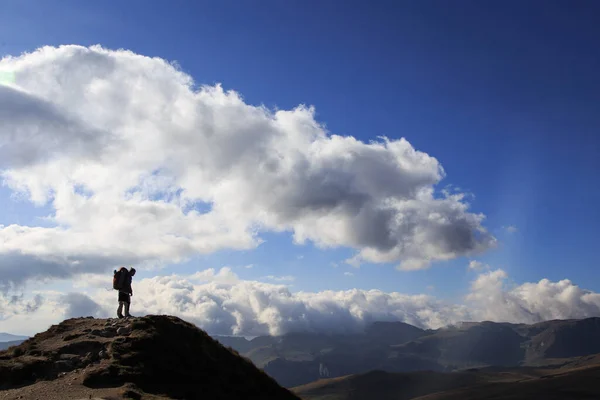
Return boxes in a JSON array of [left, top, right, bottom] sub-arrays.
[[0, 0, 600, 335]]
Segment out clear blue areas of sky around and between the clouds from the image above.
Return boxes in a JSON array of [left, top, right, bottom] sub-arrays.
[[0, 1, 600, 304]]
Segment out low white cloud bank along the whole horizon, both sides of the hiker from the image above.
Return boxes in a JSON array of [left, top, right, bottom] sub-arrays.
[[0, 268, 600, 336]]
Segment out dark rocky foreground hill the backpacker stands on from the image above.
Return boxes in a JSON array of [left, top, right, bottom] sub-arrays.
[[0, 316, 297, 400]]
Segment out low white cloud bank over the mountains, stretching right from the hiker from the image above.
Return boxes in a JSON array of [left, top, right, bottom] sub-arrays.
[[118, 269, 600, 336]]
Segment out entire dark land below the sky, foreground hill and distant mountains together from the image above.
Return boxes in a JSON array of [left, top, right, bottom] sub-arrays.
[[5, 315, 600, 400]]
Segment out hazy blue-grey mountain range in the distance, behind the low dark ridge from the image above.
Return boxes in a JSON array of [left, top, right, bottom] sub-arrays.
[[218, 318, 600, 387]]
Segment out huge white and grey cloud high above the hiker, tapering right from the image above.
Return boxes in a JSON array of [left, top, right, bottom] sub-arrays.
[[0, 46, 495, 283]]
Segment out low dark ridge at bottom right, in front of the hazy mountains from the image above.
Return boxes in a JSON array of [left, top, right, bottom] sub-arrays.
[[293, 360, 600, 400]]
